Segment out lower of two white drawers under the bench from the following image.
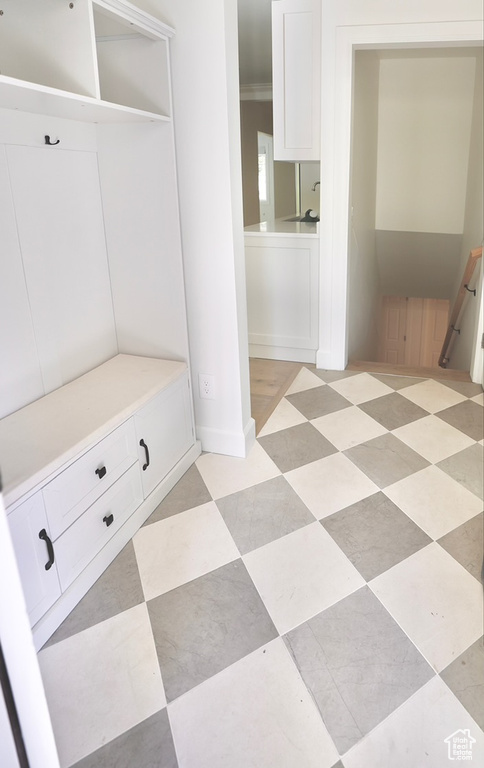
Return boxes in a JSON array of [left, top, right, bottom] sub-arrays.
[[54, 464, 143, 591]]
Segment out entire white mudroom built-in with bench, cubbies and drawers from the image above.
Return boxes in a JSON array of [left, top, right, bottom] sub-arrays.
[[0, 0, 200, 647]]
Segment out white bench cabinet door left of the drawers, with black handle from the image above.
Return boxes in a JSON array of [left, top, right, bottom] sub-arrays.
[[8, 493, 61, 626]]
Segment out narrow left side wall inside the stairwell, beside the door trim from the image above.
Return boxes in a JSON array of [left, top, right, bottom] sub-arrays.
[[348, 51, 380, 360]]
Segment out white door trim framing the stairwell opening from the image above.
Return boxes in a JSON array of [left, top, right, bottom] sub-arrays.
[[316, 21, 484, 370]]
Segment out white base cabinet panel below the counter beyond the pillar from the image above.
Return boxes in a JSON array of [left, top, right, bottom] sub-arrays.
[[245, 233, 319, 363]]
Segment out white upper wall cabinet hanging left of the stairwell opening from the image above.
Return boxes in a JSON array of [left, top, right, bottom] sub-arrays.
[[272, 0, 321, 162]]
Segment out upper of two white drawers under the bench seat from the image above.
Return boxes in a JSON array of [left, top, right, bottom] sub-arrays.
[[42, 419, 138, 540]]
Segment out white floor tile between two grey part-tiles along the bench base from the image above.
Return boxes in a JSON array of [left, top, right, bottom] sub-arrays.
[[133, 501, 240, 600]]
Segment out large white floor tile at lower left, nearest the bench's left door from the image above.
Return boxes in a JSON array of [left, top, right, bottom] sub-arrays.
[[39, 603, 166, 768]]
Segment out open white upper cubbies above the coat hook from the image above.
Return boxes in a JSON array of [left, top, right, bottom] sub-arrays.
[[0, 0, 173, 122]]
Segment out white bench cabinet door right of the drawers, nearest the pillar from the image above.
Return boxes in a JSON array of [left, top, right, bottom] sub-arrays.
[[134, 373, 194, 498]]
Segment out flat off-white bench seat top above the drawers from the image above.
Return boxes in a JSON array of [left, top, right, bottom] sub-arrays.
[[0, 355, 187, 505]]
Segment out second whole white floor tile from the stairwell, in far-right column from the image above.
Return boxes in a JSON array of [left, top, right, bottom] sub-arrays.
[[393, 416, 475, 464]]
